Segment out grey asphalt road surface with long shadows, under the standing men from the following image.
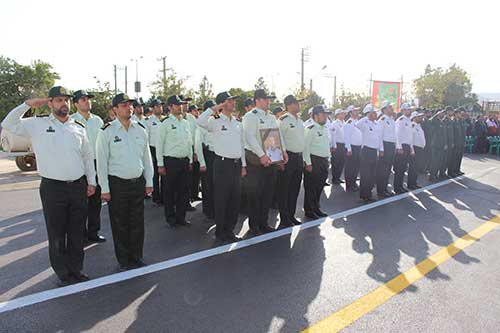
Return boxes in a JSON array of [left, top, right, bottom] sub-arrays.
[[0, 151, 500, 332]]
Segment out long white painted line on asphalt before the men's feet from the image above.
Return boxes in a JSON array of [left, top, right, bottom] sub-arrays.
[[0, 168, 496, 313]]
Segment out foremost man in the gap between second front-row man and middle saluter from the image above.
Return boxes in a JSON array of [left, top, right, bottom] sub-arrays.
[[156, 95, 193, 228]]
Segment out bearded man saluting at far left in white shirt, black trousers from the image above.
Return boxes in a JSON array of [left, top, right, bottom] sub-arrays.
[[2, 86, 96, 286]]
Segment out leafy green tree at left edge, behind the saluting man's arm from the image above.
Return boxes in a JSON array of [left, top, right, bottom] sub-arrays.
[[0, 56, 59, 120]]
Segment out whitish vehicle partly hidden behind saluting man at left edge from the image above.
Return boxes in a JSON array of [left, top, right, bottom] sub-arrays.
[[0, 128, 36, 171]]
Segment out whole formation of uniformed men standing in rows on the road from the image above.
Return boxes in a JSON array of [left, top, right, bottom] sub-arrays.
[[2, 86, 466, 285]]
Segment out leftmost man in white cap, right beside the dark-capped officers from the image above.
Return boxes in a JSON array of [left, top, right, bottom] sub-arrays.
[[329, 109, 346, 185]]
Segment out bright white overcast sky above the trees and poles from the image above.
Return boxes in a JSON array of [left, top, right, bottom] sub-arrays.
[[0, 0, 500, 104]]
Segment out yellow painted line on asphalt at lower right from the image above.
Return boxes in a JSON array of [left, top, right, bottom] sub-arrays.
[[302, 215, 500, 333]]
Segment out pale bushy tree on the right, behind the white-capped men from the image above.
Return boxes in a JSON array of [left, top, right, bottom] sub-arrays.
[[413, 64, 477, 108]]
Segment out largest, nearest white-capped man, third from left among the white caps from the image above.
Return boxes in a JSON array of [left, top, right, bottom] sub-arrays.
[[356, 104, 381, 202]]
